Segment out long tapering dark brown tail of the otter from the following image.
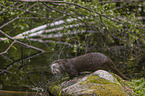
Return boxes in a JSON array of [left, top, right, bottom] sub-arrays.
[[109, 60, 130, 80]]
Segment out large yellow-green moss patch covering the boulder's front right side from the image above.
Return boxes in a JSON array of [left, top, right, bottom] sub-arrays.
[[79, 75, 127, 96]]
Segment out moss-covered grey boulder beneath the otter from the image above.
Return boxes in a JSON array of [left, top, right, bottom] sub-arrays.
[[49, 70, 133, 96]]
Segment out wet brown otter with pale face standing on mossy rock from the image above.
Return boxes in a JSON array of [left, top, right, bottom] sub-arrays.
[[51, 52, 129, 80]]
